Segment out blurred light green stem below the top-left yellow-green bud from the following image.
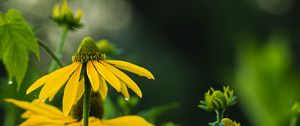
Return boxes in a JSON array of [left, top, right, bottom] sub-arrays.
[[48, 25, 69, 73]]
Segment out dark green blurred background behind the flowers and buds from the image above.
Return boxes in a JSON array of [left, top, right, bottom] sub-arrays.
[[0, 0, 300, 126]]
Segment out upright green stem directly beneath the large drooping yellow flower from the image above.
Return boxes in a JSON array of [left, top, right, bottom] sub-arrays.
[[83, 64, 91, 126]]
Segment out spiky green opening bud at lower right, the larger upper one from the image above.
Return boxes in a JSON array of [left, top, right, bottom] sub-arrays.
[[198, 86, 236, 111]]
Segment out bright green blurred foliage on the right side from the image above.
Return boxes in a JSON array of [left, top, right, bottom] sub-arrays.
[[236, 34, 298, 126]]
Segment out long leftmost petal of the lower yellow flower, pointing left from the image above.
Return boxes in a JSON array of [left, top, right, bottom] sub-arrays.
[[5, 99, 64, 118]]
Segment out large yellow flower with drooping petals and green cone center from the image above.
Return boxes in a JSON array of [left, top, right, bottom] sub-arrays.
[[26, 37, 154, 115]]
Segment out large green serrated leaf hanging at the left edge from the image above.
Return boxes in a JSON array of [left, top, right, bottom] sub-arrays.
[[0, 9, 39, 88]]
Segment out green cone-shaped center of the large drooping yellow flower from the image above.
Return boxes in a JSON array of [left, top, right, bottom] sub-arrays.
[[72, 37, 105, 63]]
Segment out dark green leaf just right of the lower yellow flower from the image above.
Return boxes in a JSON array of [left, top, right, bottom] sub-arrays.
[[138, 103, 178, 123]]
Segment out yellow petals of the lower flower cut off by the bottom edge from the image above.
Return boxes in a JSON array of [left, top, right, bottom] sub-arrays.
[[5, 99, 153, 126]]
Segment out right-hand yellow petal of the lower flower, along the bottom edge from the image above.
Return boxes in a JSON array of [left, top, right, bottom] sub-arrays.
[[103, 116, 153, 126]]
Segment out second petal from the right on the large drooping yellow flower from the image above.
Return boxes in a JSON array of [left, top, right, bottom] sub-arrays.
[[100, 61, 142, 98]]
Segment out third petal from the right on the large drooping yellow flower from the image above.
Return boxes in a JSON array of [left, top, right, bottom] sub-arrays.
[[92, 61, 121, 92]]
